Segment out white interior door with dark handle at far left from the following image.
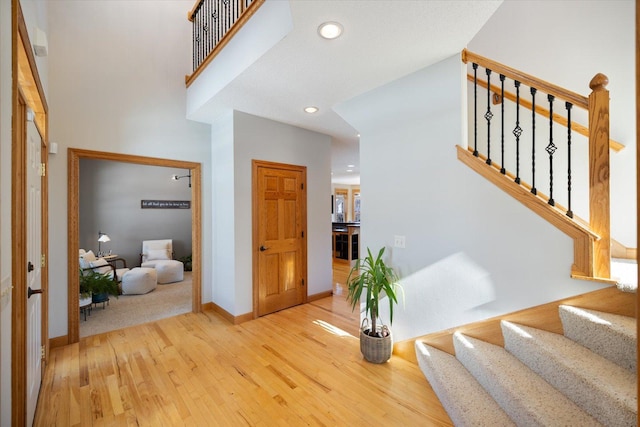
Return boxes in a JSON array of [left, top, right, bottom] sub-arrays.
[[27, 118, 42, 425]]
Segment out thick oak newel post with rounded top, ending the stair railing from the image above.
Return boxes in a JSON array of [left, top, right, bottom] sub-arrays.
[[589, 73, 611, 278]]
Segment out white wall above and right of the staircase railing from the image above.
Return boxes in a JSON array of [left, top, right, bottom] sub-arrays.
[[468, 0, 637, 248]]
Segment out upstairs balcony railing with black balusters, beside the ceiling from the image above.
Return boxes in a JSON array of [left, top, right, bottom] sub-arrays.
[[185, 0, 265, 87]]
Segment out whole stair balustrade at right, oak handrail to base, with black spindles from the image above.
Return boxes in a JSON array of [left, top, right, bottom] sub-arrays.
[[458, 50, 623, 279]]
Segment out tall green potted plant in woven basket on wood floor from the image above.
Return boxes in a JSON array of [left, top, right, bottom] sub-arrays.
[[347, 247, 402, 363]]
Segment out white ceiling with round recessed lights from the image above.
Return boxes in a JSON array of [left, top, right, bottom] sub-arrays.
[[192, 0, 502, 183]]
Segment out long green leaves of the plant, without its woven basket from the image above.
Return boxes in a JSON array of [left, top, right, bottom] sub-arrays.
[[347, 247, 402, 336]]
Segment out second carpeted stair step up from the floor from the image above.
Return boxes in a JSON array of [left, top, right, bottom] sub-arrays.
[[453, 332, 601, 426]]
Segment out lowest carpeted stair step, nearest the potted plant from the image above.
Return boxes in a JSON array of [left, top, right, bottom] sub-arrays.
[[415, 340, 515, 427]]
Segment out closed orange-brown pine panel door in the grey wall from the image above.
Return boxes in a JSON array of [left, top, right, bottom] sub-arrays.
[[253, 160, 307, 316]]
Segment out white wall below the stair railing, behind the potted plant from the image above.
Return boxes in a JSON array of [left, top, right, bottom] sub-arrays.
[[337, 55, 600, 340]]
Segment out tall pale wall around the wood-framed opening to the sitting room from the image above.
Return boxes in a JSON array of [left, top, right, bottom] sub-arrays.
[[48, 0, 212, 338]]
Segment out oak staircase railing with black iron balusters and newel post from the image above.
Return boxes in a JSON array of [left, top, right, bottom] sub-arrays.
[[458, 49, 619, 283]]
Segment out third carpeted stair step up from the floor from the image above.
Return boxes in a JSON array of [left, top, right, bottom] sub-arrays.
[[501, 320, 637, 426]]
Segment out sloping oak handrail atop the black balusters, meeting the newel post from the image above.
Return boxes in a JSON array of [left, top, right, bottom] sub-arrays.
[[461, 49, 589, 110]]
